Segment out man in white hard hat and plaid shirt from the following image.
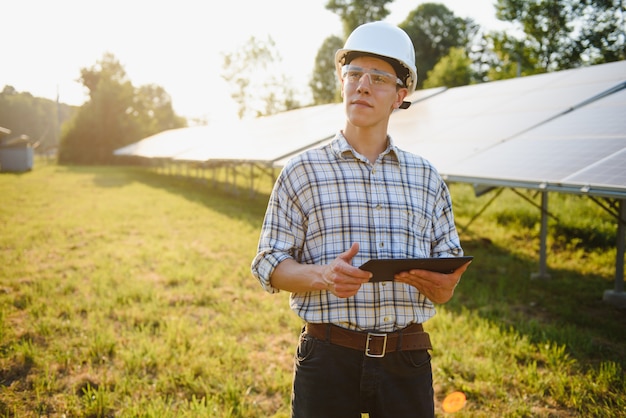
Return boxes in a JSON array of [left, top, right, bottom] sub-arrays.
[[252, 22, 467, 418]]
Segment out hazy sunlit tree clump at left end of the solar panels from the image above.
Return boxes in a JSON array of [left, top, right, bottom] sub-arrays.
[[59, 53, 186, 164]]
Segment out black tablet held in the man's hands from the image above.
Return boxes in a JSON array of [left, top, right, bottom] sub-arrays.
[[359, 255, 474, 282]]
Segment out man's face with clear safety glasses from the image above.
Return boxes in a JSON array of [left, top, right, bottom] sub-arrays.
[[341, 56, 408, 127]]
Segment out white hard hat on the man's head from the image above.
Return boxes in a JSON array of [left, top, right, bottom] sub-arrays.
[[335, 22, 417, 98]]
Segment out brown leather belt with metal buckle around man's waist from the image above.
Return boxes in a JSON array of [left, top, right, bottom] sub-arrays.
[[305, 322, 433, 357]]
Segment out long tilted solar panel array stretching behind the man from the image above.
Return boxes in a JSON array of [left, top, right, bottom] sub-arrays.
[[116, 61, 626, 198]]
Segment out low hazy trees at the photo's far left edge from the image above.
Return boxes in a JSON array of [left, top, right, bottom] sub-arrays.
[[0, 86, 76, 152]]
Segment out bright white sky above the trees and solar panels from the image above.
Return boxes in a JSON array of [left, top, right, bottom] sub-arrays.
[[0, 0, 502, 123]]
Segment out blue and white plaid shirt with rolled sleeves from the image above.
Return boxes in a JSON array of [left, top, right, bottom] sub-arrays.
[[252, 133, 463, 332]]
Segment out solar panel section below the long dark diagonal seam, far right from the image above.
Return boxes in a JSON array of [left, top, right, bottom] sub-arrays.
[[447, 75, 626, 195]]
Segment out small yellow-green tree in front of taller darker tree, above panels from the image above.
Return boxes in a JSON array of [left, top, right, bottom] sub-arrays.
[[423, 47, 473, 88]]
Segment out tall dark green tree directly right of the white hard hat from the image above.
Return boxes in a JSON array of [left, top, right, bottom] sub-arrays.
[[400, 3, 479, 88]]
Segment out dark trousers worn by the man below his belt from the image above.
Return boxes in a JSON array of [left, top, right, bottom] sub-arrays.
[[291, 333, 435, 418]]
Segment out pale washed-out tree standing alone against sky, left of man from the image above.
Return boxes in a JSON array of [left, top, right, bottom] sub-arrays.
[[222, 36, 298, 118]]
